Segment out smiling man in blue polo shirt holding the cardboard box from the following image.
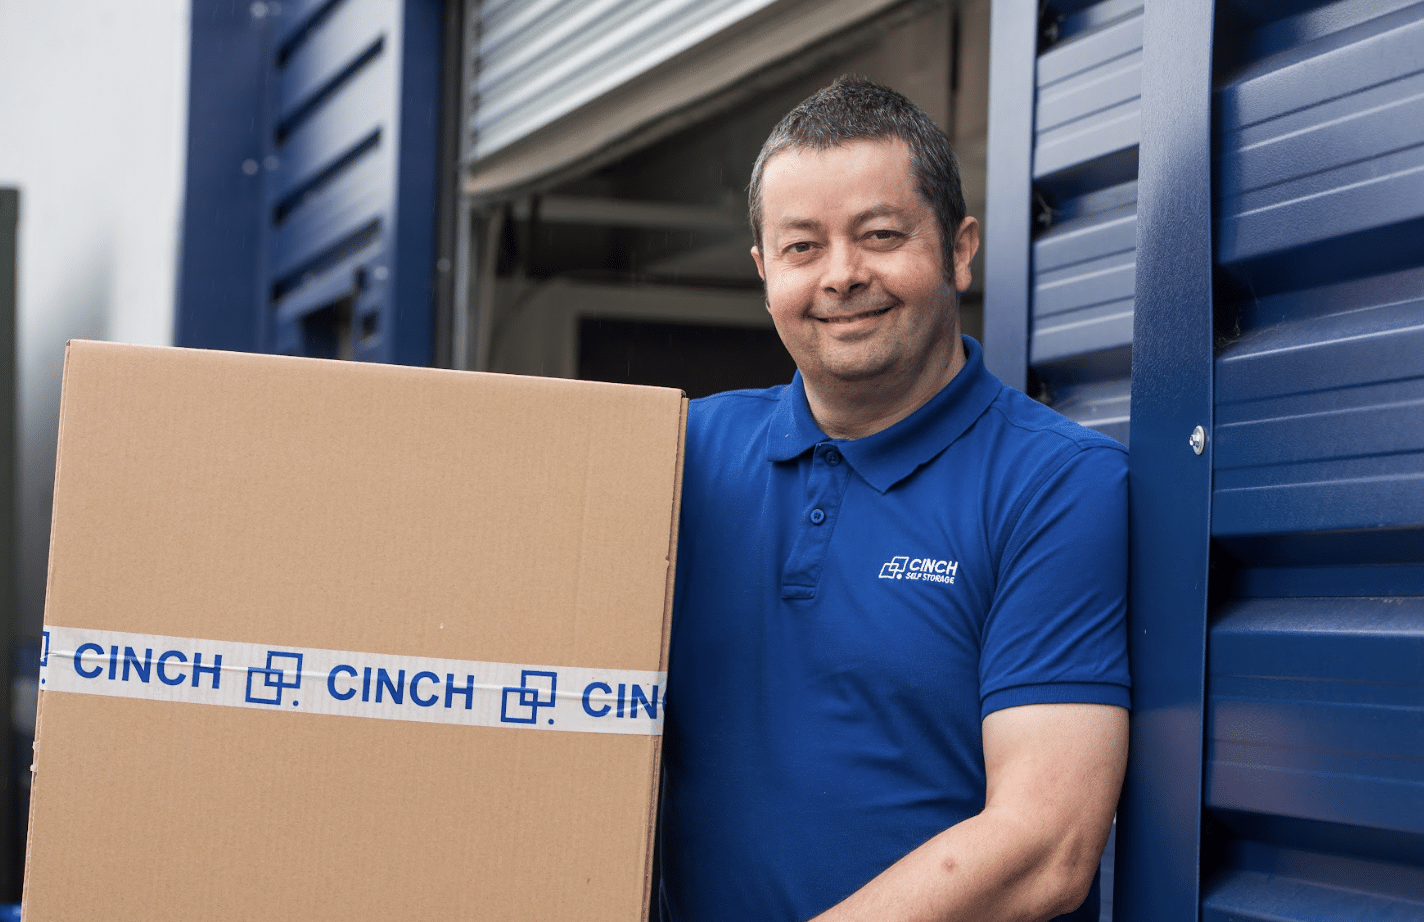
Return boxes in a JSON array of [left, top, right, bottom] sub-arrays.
[[661, 78, 1128, 922]]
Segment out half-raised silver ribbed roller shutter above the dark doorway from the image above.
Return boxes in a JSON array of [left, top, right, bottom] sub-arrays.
[[463, 0, 903, 201]]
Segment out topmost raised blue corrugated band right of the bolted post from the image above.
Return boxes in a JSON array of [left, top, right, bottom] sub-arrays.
[[1218, 4, 1424, 264]]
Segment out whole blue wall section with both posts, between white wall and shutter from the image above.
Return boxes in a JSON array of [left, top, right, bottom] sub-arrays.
[[175, 0, 443, 365]]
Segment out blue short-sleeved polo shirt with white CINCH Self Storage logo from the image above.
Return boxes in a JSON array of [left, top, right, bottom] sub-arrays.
[[661, 338, 1128, 922]]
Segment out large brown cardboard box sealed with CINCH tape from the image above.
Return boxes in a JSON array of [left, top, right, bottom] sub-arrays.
[[24, 342, 686, 922]]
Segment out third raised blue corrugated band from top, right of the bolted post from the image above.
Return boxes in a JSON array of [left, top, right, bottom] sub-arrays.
[[1206, 597, 1424, 842]]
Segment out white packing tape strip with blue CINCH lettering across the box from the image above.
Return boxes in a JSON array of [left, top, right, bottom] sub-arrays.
[[40, 627, 666, 735]]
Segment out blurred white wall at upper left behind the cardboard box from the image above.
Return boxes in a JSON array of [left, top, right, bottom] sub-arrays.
[[0, 0, 189, 637]]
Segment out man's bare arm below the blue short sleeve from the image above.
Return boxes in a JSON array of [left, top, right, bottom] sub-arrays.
[[816, 704, 1128, 922]]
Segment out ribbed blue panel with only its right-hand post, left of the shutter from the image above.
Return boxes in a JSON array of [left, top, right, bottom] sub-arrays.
[[250, 0, 440, 363]]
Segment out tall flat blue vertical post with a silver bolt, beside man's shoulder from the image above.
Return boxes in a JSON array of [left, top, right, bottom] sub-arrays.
[[1114, 1, 1213, 922]]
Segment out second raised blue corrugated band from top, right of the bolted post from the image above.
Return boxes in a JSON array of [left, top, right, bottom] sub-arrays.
[[1212, 265, 1424, 546]]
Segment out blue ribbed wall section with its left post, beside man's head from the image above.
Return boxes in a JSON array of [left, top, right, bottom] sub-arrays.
[[985, 0, 1142, 442]]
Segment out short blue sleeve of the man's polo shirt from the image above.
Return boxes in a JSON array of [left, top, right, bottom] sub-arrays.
[[980, 445, 1131, 718]]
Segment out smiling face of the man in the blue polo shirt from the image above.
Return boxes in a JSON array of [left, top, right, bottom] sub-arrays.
[[752, 140, 978, 395]]
